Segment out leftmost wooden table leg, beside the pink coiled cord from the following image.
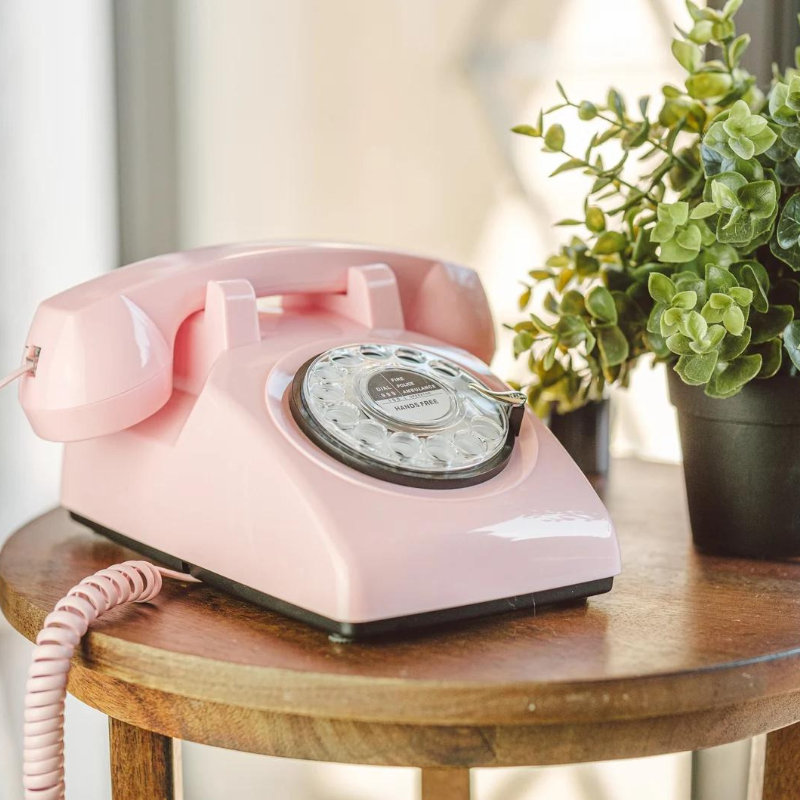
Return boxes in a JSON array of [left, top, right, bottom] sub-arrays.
[[108, 717, 183, 800]]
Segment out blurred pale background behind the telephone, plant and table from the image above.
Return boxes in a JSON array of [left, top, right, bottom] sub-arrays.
[[0, 0, 796, 800]]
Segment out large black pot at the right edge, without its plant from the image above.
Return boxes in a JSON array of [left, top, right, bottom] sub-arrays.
[[669, 370, 800, 558]]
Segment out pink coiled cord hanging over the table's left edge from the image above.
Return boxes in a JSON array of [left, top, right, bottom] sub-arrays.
[[23, 561, 196, 800]]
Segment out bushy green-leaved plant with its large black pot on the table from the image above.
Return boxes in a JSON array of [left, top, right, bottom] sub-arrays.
[[513, 0, 800, 558]]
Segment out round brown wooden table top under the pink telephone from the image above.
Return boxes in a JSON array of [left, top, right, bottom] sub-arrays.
[[0, 461, 800, 766]]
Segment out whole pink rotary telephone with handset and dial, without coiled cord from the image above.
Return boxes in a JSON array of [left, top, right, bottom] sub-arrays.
[[20, 242, 620, 637]]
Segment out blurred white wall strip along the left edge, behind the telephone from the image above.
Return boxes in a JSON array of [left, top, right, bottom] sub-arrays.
[[0, 0, 117, 800]]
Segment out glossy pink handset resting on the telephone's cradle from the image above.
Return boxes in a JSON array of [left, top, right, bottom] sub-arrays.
[[20, 243, 494, 442]]
